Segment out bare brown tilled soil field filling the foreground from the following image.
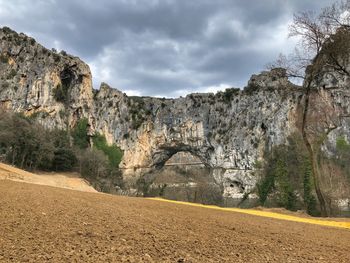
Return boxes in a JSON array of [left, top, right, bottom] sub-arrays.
[[0, 180, 350, 262]]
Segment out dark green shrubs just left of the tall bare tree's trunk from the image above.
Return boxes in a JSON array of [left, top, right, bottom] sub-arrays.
[[257, 134, 308, 213]]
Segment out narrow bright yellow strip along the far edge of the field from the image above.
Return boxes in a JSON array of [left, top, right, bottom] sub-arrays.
[[148, 198, 350, 229]]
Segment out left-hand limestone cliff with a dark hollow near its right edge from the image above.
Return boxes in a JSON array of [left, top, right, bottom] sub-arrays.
[[0, 28, 93, 128]]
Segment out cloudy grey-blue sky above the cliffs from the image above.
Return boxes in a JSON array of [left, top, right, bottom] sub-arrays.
[[0, 0, 334, 97]]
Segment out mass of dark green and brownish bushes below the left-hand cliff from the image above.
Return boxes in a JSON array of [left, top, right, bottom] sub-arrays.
[[0, 112, 123, 192]]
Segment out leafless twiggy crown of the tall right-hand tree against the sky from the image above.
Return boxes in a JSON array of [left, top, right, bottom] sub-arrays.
[[267, 0, 350, 79]]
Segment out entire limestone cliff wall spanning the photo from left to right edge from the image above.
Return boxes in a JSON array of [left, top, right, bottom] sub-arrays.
[[0, 28, 350, 202]]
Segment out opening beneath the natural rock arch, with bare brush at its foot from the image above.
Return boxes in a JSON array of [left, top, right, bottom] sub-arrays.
[[142, 151, 222, 205]]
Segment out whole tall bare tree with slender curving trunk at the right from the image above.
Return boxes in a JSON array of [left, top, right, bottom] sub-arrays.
[[268, 0, 350, 216]]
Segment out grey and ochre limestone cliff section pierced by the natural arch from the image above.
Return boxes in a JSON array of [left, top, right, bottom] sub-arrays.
[[95, 69, 302, 196]]
